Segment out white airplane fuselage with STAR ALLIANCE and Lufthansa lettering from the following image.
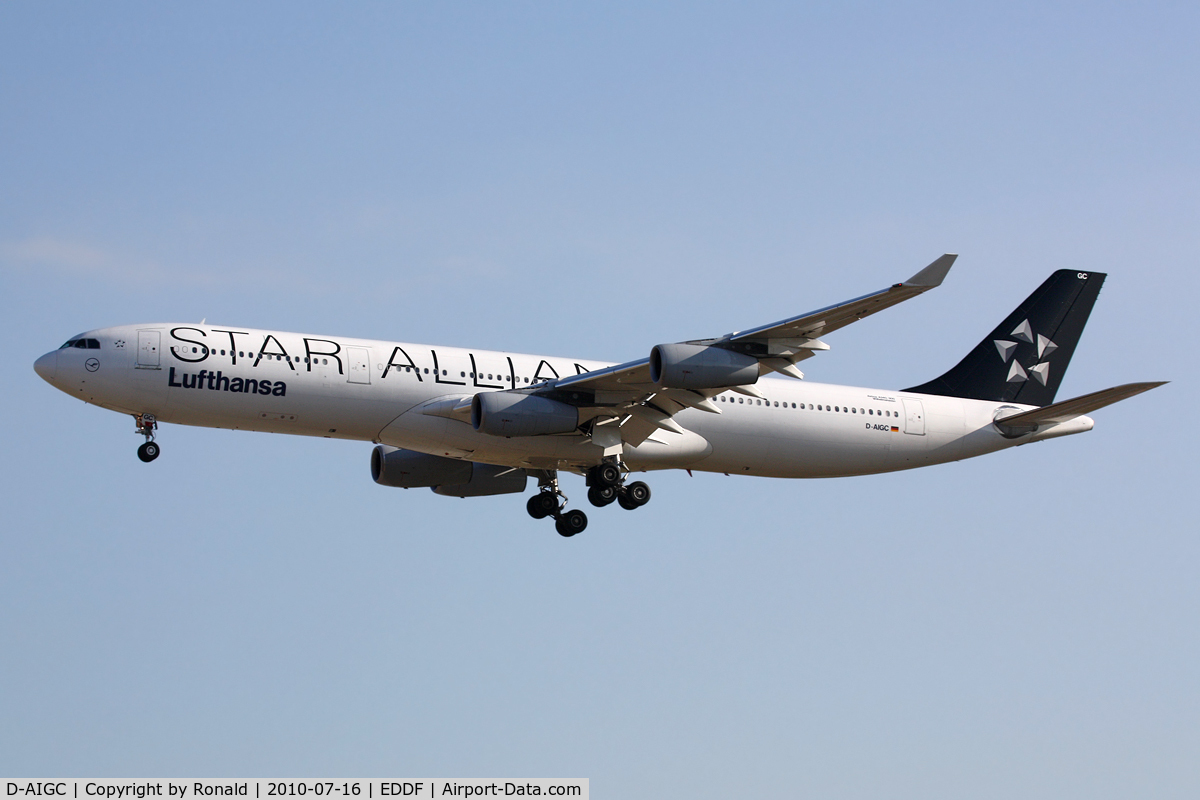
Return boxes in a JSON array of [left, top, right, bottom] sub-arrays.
[[37, 324, 1092, 477]]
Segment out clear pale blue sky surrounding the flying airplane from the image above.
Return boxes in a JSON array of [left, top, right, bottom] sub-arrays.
[[0, 2, 1200, 798]]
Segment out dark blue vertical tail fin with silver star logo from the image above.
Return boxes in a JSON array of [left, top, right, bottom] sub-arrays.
[[905, 270, 1106, 405]]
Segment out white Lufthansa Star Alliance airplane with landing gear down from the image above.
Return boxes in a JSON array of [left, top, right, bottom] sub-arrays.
[[34, 253, 1165, 537]]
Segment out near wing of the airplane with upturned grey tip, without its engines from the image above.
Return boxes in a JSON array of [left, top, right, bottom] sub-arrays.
[[520, 253, 958, 445]]
